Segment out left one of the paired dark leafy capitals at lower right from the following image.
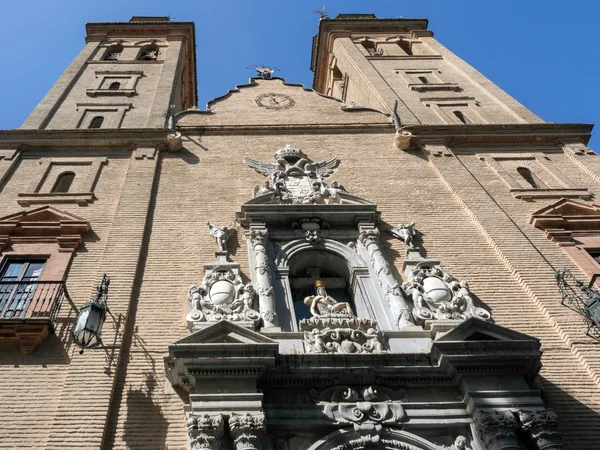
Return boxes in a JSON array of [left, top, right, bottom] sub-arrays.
[[473, 411, 522, 450]]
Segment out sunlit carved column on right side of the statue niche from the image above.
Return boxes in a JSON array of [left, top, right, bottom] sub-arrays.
[[358, 225, 415, 328]]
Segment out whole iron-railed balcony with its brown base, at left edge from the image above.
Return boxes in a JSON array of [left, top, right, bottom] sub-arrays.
[[0, 281, 70, 353]]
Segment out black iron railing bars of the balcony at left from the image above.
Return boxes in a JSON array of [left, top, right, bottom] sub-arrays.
[[0, 281, 69, 322]]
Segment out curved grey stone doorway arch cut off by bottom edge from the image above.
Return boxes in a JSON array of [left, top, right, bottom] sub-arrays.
[[307, 428, 441, 450]]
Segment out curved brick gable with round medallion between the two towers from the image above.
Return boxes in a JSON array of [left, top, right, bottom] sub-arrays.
[[176, 78, 393, 129]]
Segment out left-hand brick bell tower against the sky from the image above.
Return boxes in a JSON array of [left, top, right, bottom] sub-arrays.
[[21, 17, 197, 129]]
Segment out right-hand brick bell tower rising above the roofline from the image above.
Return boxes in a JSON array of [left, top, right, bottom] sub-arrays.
[[311, 14, 542, 125]]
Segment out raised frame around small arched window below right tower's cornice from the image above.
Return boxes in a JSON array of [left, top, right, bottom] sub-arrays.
[[477, 153, 592, 199]]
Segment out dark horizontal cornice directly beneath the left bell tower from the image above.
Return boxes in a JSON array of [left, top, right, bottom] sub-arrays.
[[0, 128, 171, 150]]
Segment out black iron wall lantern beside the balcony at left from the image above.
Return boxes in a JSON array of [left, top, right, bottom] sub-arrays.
[[73, 274, 110, 354]]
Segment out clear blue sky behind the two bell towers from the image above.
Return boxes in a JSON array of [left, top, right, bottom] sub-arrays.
[[0, 0, 600, 150]]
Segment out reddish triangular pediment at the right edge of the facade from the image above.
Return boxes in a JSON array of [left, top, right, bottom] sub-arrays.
[[530, 198, 600, 245]]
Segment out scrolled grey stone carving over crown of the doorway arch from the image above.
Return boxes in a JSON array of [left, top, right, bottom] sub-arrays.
[[311, 385, 407, 445]]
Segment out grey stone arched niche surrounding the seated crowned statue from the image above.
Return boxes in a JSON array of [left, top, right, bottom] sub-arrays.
[[274, 239, 392, 331]]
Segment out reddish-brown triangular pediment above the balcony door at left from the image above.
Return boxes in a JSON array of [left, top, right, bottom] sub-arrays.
[[0, 206, 91, 248]]
